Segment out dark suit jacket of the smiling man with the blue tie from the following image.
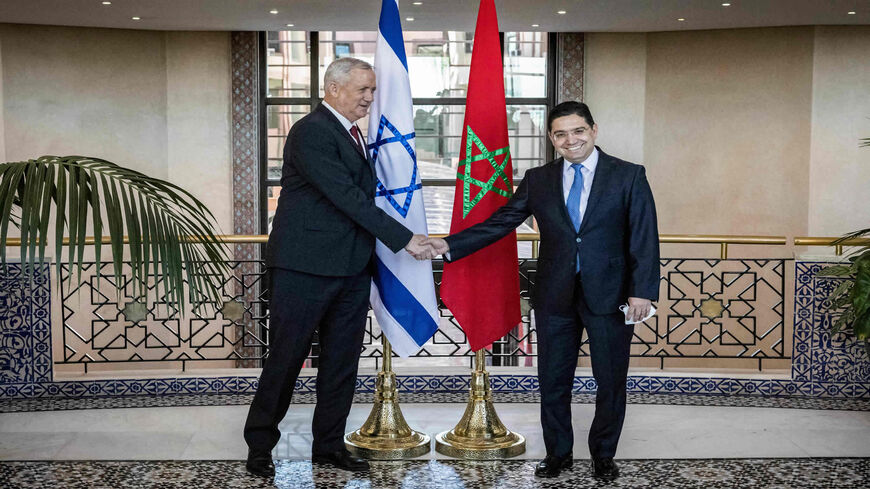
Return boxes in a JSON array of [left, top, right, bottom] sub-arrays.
[[447, 149, 659, 314]]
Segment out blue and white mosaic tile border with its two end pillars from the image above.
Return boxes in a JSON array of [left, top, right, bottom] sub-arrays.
[[0, 262, 870, 399]]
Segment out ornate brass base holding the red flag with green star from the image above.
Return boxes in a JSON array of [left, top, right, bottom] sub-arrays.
[[435, 350, 526, 460]]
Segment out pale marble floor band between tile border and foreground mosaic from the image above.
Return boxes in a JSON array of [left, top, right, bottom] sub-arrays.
[[0, 398, 870, 461]]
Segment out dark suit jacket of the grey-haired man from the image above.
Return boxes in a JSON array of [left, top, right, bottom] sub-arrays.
[[266, 105, 413, 276]]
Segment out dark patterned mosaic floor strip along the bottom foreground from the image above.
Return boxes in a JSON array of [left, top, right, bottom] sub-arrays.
[[0, 458, 870, 489]]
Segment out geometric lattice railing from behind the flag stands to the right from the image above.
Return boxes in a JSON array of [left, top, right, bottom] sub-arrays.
[[361, 258, 792, 368]]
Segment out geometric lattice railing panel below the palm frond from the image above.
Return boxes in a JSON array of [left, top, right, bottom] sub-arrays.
[[56, 261, 266, 368]]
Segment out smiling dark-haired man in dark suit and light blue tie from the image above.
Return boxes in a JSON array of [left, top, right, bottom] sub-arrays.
[[426, 102, 659, 480]]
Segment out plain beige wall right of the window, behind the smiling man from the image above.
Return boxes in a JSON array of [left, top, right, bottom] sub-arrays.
[[586, 27, 870, 250]]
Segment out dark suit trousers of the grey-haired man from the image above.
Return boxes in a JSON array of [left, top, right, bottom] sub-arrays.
[[245, 268, 371, 453]]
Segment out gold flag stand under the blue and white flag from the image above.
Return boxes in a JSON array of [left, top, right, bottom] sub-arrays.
[[344, 335, 429, 460]]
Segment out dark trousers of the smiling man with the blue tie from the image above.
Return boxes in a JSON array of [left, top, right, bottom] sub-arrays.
[[535, 280, 634, 458]]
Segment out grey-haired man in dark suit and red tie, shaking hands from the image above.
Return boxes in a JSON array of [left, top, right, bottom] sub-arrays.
[[245, 58, 432, 476]]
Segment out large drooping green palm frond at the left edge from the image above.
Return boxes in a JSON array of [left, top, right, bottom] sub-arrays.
[[0, 156, 230, 312]]
